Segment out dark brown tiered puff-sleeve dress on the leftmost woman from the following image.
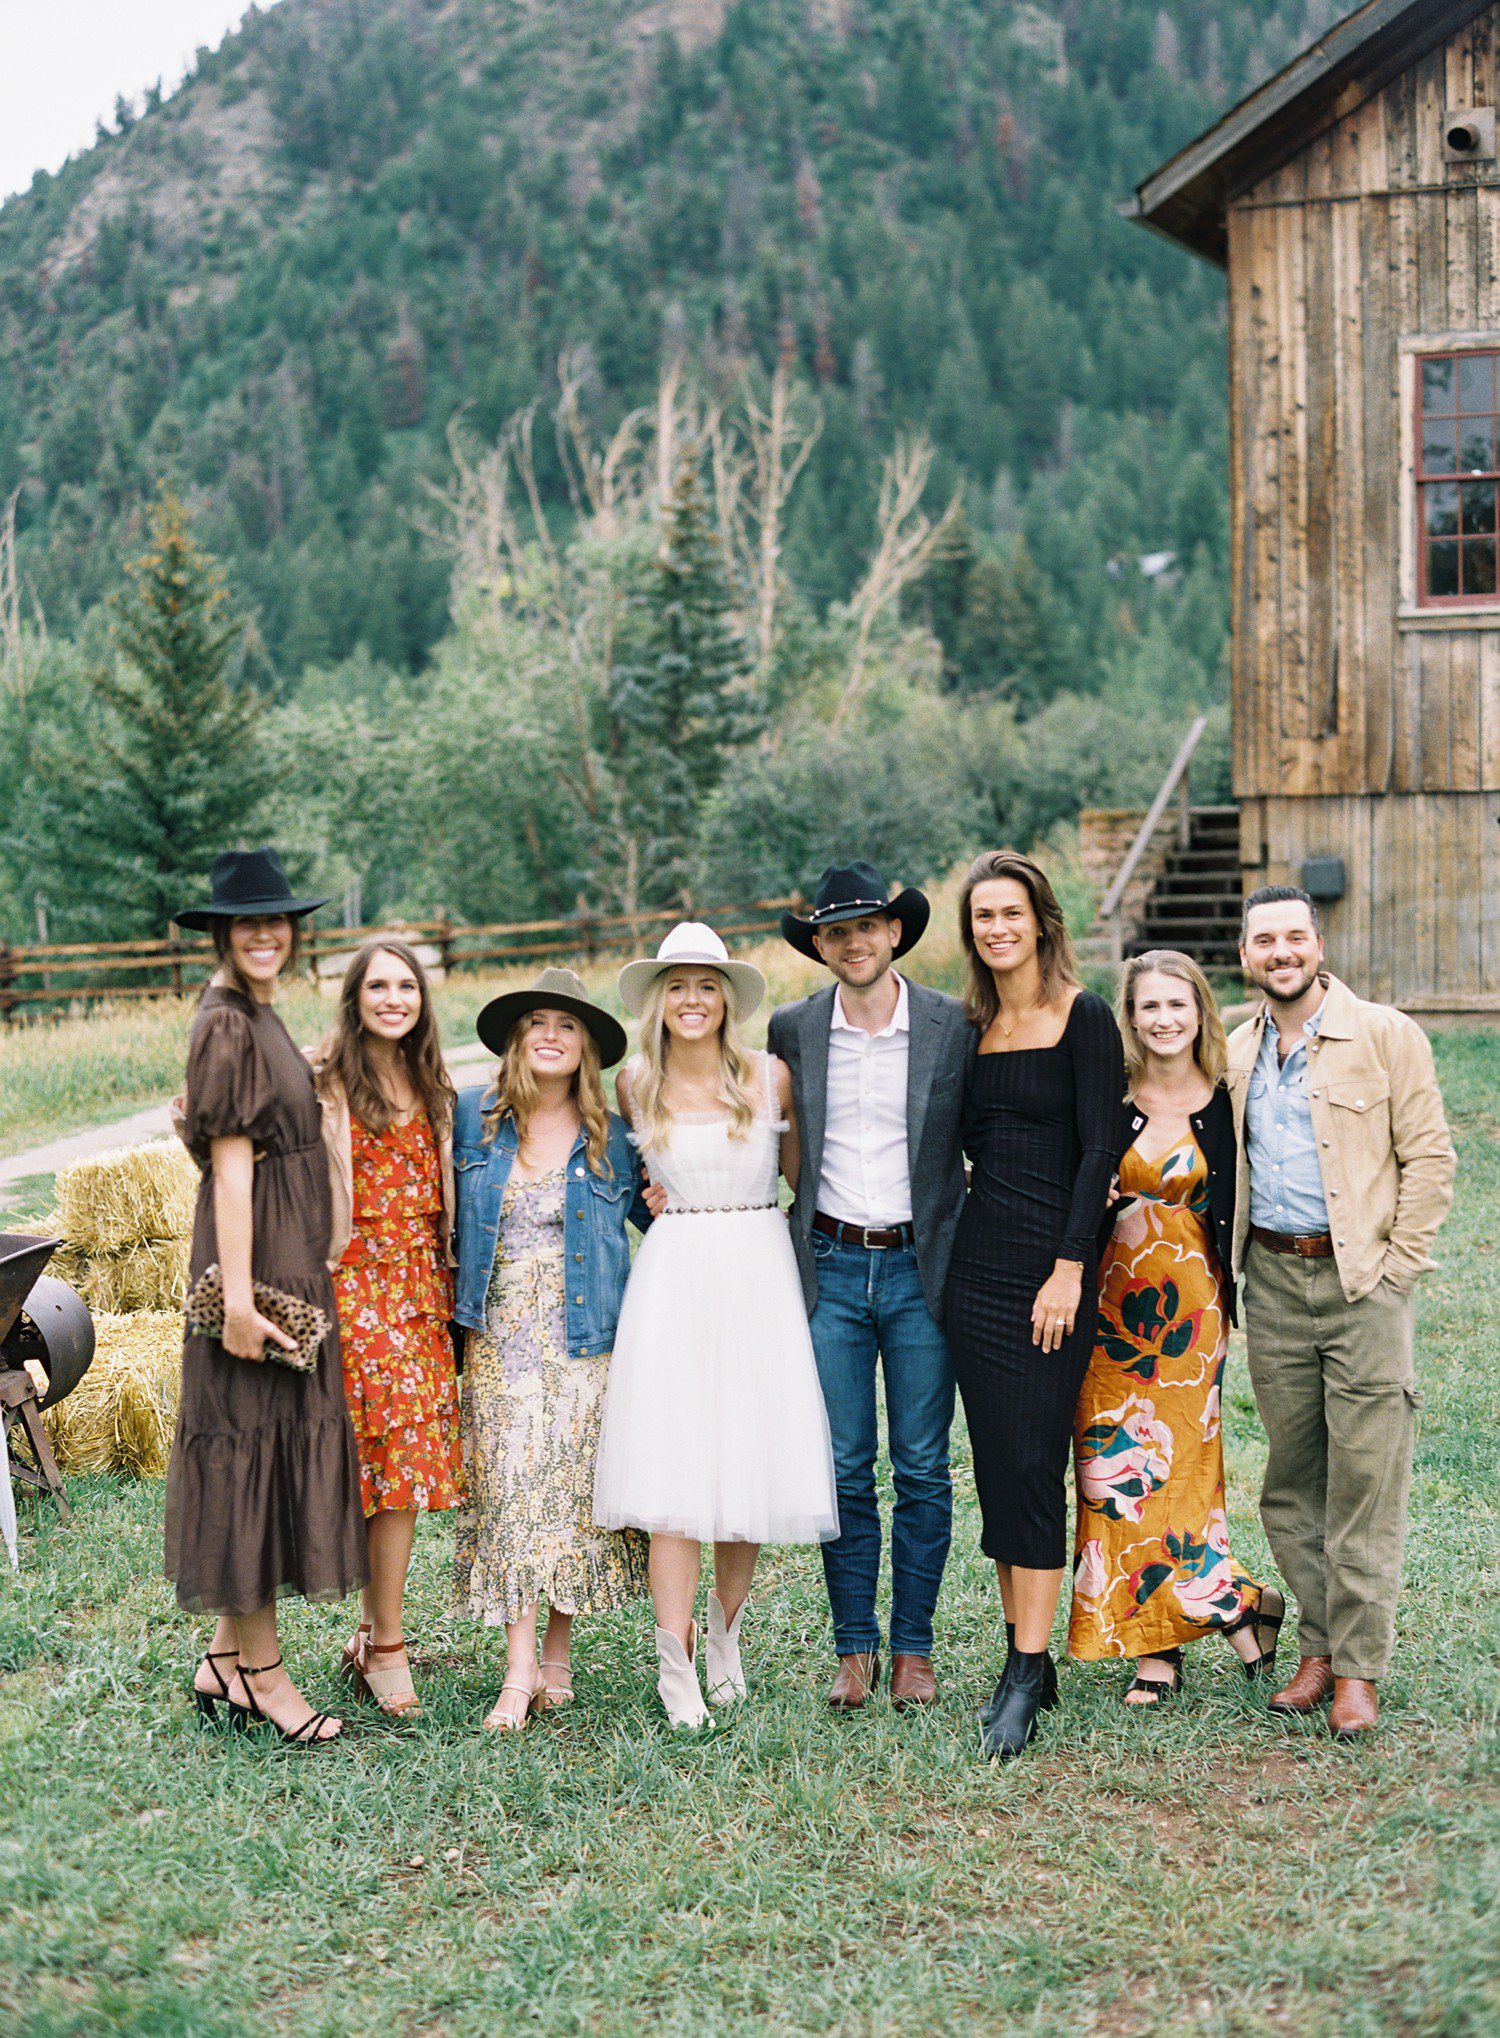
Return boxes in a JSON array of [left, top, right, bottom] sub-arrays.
[[167, 988, 367, 1614]]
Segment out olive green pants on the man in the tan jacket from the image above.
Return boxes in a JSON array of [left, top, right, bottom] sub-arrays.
[[1243, 1241, 1421, 1679]]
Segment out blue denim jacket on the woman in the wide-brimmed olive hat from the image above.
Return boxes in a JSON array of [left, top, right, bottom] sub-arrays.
[[452, 1084, 650, 1359]]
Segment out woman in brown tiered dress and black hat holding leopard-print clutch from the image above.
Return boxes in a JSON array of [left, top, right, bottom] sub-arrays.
[[167, 850, 365, 1745]]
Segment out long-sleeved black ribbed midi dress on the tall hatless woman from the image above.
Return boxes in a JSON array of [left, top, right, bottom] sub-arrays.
[[946, 990, 1125, 1571]]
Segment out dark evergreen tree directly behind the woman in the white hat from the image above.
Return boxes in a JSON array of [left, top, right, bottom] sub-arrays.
[[601, 444, 756, 909]]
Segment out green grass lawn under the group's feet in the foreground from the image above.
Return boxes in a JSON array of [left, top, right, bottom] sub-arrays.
[[0, 1037, 1500, 2038]]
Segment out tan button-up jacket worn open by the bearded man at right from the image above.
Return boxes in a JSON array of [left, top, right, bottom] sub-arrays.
[[1229, 974, 1455, 1302]]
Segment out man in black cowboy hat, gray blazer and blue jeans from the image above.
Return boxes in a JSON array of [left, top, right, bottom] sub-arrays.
[[768, 862, 974, 1712]]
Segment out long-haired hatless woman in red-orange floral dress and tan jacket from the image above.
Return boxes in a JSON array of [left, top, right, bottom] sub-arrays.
[[318, 940, 463, 1718]]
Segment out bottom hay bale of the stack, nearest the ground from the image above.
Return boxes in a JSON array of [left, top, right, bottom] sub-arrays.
[[43, 1310, 181, 1480]]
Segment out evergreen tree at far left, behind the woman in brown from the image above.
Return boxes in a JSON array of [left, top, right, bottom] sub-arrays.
[[39, 489, 269, 935]]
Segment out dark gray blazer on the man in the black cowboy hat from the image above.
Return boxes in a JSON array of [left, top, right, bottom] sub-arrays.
[[766, 976, 976, 1323]]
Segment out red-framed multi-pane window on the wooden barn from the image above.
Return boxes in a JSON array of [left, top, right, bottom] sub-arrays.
[[1416, 348, 1500, 607]]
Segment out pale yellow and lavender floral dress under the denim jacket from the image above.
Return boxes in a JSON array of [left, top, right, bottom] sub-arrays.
[[454, 1168, 648, 1626]]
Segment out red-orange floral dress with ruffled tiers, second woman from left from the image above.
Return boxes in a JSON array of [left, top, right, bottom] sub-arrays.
[[334, 1111, 463, 1516]]
